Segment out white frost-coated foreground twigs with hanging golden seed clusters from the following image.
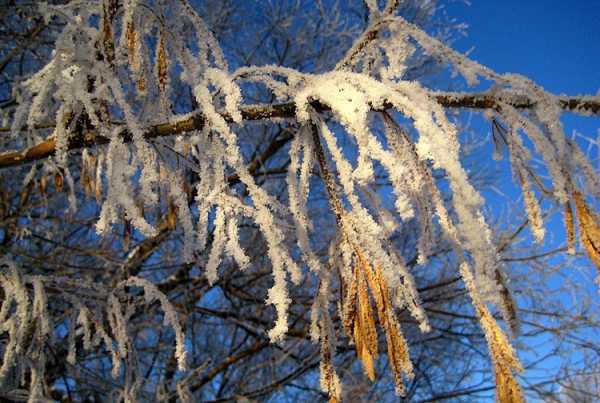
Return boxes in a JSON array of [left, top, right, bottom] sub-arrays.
[[0, 0, 600, 401]]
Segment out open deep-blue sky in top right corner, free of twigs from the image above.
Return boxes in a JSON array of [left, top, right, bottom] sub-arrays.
[[447, 0, 600, 95]]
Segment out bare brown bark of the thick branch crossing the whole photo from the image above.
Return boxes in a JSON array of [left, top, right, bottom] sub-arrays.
[[0, 92, 600, 169]]
